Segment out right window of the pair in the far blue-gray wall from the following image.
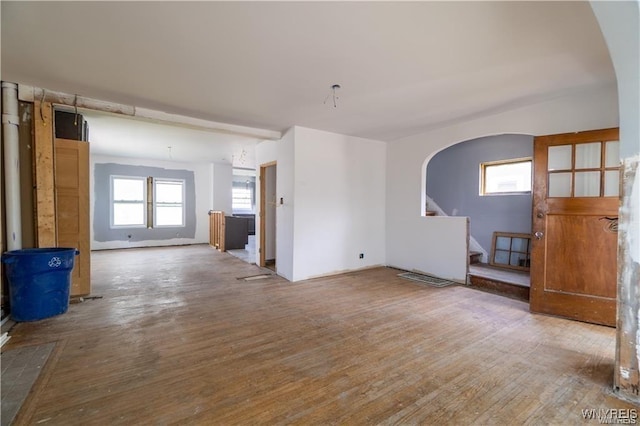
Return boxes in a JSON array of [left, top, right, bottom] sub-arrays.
[[153, 179, 184, 227]]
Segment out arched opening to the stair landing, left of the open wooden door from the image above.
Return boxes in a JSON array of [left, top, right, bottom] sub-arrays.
[[425, 134, 533, 302]]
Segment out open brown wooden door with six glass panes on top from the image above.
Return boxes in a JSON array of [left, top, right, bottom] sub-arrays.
[[531, 129, 620, 326]]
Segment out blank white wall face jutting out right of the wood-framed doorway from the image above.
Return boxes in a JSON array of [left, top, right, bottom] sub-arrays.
[[290, 126, 386, 281]]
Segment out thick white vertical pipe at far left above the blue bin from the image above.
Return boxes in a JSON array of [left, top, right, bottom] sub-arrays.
[[2, 81, 22, 250]]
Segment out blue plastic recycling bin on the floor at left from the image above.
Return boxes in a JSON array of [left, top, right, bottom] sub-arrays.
[[1, 247, 80, 322]]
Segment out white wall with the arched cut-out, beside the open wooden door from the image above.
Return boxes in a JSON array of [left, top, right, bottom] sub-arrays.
[[386, 84, 618, 281]]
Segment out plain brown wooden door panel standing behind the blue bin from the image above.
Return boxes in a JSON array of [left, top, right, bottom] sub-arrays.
[[54, 139, 91, 296]]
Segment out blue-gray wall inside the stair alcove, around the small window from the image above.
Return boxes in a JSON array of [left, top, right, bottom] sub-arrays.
[[427, 135, 533, 253]]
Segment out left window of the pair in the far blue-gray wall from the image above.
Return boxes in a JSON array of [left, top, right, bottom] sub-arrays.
[[111, 176, 147, 227]]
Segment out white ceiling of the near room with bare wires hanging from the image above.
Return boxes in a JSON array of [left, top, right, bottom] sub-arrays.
[[1, 1, 615, 151]]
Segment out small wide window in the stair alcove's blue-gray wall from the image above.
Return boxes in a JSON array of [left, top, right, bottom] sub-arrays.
[[480, 158, 532, 195]]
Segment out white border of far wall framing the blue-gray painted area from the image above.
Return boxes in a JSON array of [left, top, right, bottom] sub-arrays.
[[90, 155, 212, 250]]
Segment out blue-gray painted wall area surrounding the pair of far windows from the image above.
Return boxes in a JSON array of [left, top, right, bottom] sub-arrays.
[[93, 163, 196, 242]]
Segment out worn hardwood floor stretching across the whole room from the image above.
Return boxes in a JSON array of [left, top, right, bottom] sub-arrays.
[[3, 246, 635, 425]]
